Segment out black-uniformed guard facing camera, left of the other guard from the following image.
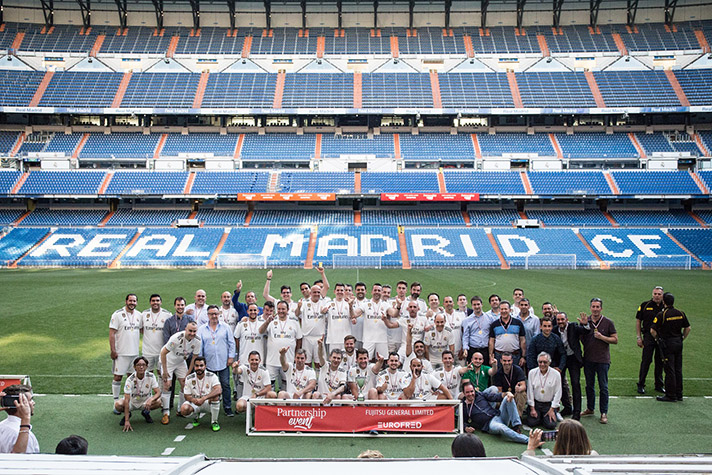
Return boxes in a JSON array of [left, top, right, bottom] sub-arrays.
[[635, 286, 665, 394]]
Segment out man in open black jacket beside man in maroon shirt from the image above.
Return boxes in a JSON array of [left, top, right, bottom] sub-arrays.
[[553, 312, 585, 421]]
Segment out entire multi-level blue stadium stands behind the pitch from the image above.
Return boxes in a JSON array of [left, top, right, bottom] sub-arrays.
[[0, 7, 712, 268]]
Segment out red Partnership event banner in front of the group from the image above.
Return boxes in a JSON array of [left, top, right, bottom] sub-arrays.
[[255, 404, 456, 432]]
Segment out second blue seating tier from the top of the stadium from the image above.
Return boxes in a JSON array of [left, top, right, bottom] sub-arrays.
[[0, 69, 712, 109]]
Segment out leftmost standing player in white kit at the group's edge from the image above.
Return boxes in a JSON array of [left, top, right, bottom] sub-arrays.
[[109, 294, 142, 415]]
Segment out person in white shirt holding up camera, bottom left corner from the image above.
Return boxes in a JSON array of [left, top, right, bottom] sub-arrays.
[[0, 384, 40, 454]]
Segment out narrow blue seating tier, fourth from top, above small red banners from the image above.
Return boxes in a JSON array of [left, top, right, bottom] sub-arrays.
[[0, 170, 710, 197]]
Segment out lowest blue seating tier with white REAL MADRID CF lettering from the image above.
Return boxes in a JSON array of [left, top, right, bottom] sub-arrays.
[[0, 224, 710, 268]]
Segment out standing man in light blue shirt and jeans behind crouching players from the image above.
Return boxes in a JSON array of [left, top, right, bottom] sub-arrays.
[[198, 305, 235, 417]]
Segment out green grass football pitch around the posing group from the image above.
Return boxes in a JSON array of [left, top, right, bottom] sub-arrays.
[[0, 269, 712, 457]]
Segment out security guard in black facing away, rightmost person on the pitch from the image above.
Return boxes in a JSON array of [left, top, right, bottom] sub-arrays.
[[650, 292, 690, 402]]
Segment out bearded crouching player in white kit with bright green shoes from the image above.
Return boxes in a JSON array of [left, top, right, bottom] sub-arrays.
[[180, 356, 222, 432]]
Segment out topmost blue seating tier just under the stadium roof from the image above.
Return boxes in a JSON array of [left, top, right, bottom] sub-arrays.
[[0, 21, 712, 55]]
